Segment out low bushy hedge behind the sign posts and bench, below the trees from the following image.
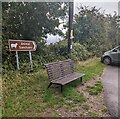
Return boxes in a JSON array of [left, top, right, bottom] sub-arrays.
[[3, 40, 92, 72]]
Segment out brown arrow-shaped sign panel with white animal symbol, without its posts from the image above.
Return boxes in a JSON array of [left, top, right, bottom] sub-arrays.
[[8, 40, 36, 51]]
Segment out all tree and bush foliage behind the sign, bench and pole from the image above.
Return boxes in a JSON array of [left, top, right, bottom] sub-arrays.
[[2, 2, 120, 71]]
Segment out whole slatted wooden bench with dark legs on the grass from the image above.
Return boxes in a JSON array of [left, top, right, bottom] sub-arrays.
[[45, 59, 85, 92]]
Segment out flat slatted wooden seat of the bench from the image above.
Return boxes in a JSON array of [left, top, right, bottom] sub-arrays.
[[51, 72, 85, 85]]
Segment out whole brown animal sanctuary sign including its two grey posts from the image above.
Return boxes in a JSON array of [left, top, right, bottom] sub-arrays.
[[8, 40, 36, 69]]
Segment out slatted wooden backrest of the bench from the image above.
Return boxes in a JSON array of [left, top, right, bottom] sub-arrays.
[[45, 59, 74, 80]]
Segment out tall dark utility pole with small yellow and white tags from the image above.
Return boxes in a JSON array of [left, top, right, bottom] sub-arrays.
[[68, 2, 73, 53]]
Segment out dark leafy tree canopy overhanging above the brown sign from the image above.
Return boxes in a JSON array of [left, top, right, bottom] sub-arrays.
[[2, 2, 67, 39]]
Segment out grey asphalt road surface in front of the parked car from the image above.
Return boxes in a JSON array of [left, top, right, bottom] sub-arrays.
[[102, 66, 120, 117]]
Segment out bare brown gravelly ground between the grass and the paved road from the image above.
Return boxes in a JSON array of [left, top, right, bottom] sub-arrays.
[[44, 77, 110, 117]]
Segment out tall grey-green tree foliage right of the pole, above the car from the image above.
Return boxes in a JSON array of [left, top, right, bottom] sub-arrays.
[[74, 6, 118, 55]]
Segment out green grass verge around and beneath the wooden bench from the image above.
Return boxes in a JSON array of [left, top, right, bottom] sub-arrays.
[[2, 59, 104, 117]]
